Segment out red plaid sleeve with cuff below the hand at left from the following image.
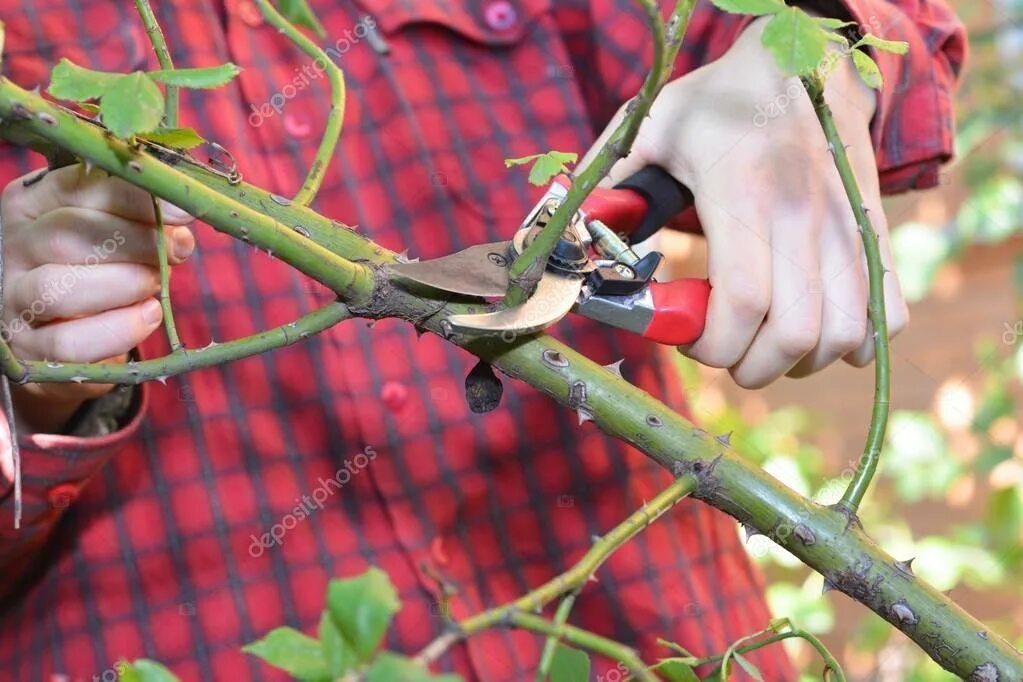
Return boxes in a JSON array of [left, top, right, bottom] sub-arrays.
[[0, 384, 148, 597]]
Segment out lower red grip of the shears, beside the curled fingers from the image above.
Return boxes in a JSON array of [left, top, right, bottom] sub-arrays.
[[642, 278, 710, 346]]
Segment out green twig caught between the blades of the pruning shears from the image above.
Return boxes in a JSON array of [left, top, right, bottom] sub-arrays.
[[504, 0, 696, 306]]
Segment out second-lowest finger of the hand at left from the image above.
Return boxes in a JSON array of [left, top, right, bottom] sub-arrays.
[[8, 263, 160, 325]]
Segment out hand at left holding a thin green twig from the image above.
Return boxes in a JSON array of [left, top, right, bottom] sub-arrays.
[[0, 165, 195, 433]]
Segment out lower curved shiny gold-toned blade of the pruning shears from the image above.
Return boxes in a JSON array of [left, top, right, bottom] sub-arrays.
[[447, 272, 583, 335]]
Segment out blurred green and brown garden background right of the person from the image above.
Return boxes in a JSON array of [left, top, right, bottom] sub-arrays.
[[664, 0, 1023, 682]]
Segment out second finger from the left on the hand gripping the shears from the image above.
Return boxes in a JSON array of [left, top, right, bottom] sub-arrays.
[[731, 201, 824, 389]]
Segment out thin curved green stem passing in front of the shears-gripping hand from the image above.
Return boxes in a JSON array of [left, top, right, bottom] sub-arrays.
[[803, 76, 891, 514]]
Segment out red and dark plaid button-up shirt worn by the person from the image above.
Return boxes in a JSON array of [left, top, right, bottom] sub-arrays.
[[0, 0, 964, 682]]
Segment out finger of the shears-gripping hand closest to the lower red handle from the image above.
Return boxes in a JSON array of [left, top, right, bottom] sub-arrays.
[[679, 196, 771, 367]]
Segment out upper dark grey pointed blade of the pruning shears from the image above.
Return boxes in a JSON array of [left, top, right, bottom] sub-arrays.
[[391, 241, 509, 298]]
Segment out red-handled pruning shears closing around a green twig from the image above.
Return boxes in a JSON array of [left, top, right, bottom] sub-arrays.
[[391, 166, 710, 346]]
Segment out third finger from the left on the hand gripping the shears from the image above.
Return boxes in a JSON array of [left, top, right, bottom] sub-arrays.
[[789, 204, 868, 377]]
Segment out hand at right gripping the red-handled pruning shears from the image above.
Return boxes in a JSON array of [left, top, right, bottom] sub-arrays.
[[588, 19, 908, 389]]
